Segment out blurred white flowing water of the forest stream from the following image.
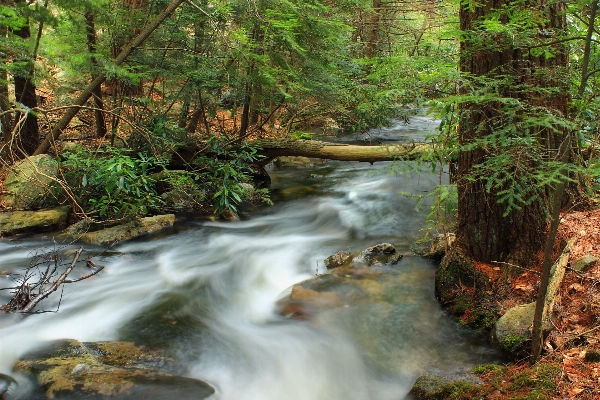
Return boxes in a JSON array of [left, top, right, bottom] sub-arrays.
[[0, 117, 497, 400]]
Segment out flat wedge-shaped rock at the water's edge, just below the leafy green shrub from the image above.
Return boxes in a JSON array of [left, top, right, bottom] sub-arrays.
[[74, 214, 175, 247]]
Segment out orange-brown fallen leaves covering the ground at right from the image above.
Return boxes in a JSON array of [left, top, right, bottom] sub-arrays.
[[460, 209, 600, 400]]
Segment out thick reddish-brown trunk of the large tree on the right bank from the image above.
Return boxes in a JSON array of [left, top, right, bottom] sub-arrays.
[[457, 0, 568, 264]]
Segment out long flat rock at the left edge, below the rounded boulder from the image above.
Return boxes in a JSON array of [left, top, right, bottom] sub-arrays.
[[0, 206, 71, 236]]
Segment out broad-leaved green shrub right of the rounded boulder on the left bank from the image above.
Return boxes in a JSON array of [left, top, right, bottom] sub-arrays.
[[61, 147, 164, 219]]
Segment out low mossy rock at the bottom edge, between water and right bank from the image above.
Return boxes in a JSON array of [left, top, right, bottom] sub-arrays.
[[409, 374, 483, 400]]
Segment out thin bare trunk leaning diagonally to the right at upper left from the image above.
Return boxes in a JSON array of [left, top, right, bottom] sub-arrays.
[[34, 0, 185, 155]]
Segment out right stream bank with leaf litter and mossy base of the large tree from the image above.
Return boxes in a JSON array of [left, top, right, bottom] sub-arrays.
[[432, 209, 600, 400]]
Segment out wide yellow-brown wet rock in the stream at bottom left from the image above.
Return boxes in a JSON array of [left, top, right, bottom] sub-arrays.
[[14, 339, 214, 400]]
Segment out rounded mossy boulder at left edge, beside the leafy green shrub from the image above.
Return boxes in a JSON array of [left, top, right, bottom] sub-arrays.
[[0, 154, 58, 209]]
